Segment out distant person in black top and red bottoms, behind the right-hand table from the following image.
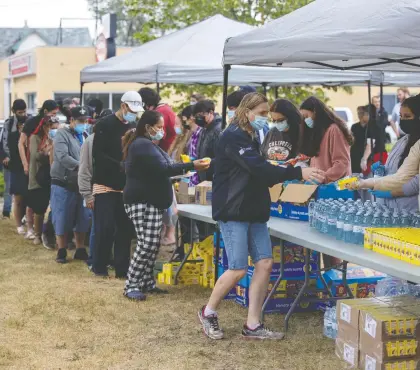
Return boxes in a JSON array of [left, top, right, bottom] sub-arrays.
[[369, 96, 389, 164]]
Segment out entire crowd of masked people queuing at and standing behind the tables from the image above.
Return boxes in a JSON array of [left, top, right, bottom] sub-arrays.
[[1, 87, 420, 339]]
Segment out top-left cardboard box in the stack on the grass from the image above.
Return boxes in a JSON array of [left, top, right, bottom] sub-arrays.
[[337, 298, 388, 329]]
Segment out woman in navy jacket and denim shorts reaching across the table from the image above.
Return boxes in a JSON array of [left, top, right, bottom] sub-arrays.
[[198, 93, 324, 339]]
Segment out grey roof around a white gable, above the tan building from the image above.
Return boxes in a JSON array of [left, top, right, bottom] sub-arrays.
[[0, 27, 92, 58]]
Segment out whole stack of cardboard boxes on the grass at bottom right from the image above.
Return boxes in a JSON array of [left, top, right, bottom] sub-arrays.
[[336, 296, 420, 370]]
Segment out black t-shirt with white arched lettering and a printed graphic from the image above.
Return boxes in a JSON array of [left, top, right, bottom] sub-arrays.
[[261, 128, 296, 161]]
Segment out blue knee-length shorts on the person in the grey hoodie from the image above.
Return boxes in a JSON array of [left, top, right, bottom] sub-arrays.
[[51, 185, 90, 236]]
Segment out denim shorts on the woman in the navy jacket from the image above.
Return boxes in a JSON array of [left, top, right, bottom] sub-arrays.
[[219, 221, 273, 270]]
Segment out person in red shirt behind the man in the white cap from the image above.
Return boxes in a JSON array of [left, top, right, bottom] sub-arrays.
[[139, 87, 176, 152]]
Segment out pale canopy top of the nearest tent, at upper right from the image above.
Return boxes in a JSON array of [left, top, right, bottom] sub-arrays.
[[224, 0, 420, 71]]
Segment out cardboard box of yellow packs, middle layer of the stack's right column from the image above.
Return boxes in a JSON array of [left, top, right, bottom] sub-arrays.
[[360, 331, 419, 362]]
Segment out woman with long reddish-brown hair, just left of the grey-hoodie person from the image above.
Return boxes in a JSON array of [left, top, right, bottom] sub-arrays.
[[27, 116, 58, 245]]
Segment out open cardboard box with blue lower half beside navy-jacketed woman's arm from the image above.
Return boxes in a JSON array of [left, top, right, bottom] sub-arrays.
[[270, 184, 318, 221]]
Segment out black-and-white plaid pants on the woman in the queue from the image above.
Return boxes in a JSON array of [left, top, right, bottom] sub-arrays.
[[124, 203, 163, 294]]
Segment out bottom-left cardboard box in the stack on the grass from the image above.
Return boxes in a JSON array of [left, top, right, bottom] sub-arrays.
[[335, 326, 359, 369]]
